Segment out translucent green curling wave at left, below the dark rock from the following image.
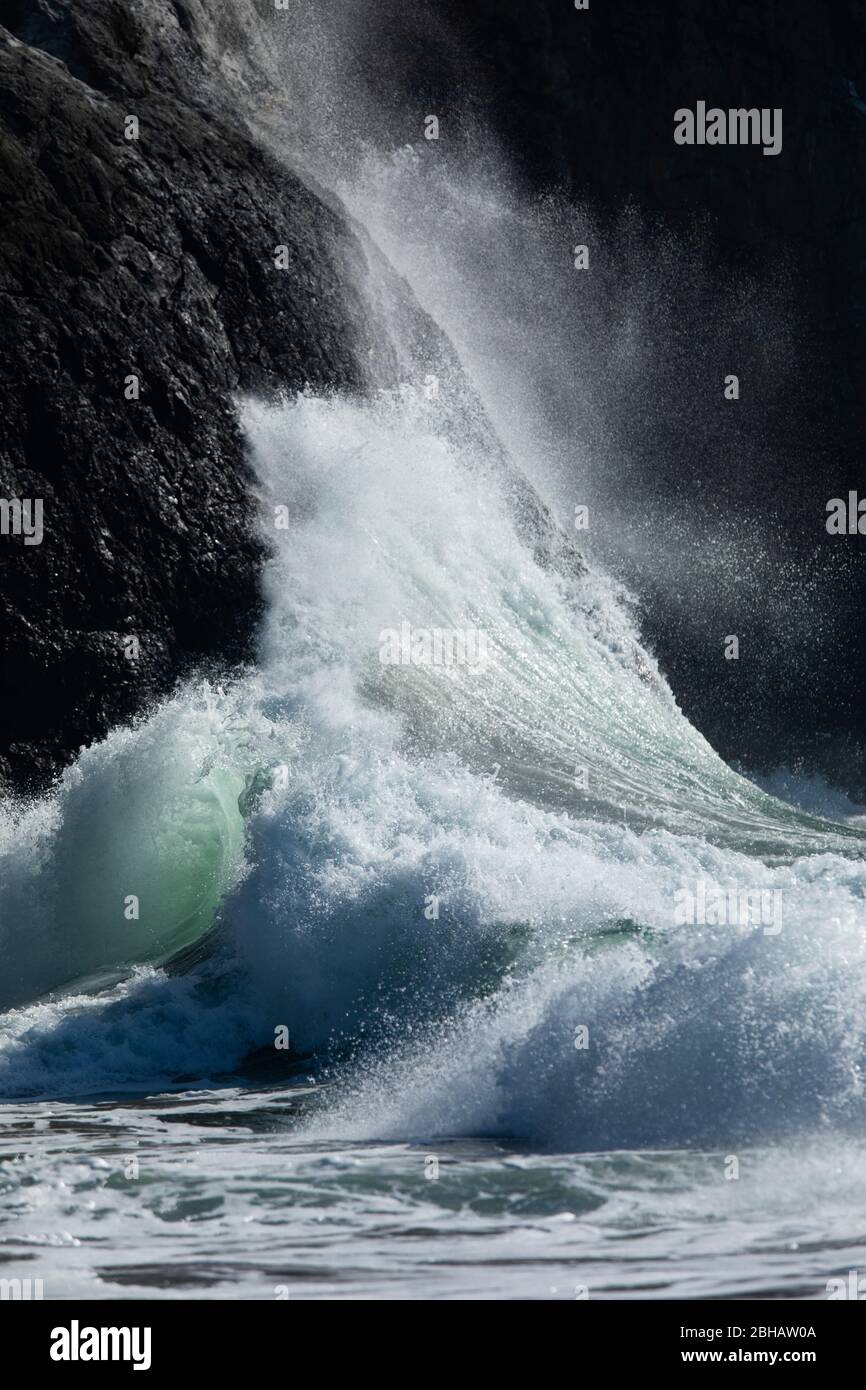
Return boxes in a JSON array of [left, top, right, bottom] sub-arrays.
[[0, 689, 245, 1008]]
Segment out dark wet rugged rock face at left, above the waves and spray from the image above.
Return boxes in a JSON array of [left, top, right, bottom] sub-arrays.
[[0, 0, 403, 788]]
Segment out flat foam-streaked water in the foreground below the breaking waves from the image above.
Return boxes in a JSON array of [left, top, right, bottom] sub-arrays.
[[0, 1087, 866, 1300]]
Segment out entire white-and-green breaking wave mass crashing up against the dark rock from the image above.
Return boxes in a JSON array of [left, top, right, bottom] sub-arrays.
[[1, 385, 866, 1148]]
